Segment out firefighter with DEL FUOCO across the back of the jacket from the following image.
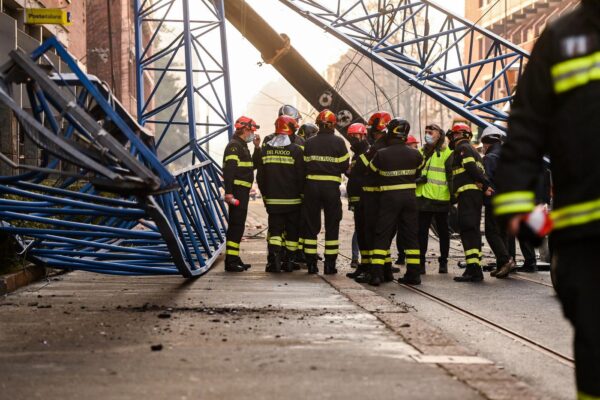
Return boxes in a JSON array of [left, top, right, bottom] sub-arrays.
[[256, 115, 304, 272]]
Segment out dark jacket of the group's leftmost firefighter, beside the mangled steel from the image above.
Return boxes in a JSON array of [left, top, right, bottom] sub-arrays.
[[223, 135, 254, 194]]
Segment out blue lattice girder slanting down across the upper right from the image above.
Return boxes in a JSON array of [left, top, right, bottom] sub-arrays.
[[280, 0, 529, 129]]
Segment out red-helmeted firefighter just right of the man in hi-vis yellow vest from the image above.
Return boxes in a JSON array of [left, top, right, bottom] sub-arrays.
[[447, 122, 493, 282]]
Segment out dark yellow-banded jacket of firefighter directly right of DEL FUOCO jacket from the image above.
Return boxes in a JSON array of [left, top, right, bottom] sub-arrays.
[[304, 129, 350, 184]]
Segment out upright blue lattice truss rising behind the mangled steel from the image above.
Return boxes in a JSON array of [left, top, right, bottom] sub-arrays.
[[135, 0, 233, 168]]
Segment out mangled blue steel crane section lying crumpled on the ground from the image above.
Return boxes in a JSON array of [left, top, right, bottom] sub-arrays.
[[0, 38, 226, 277]]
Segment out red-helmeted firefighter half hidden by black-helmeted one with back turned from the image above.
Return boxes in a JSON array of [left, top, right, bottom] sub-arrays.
[[349, 111, 394, 283]]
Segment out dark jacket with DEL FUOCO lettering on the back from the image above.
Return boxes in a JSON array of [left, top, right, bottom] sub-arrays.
[[256, 138, 304, 212]]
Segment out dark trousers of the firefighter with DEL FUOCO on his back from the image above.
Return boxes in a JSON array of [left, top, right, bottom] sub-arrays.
[[269, 207, 300, 260]]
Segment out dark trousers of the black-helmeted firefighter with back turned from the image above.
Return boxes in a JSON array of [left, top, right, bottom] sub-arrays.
[[371, 190, 421, 273]]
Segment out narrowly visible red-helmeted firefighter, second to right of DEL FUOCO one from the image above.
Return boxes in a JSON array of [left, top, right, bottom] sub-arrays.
[[346, 123, 370, 278]]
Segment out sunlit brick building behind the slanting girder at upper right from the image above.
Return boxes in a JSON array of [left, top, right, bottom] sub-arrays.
[[465, 0, 579, 104]]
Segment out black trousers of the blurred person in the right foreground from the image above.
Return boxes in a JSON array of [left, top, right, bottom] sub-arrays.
[[552, 236, 600, 399]]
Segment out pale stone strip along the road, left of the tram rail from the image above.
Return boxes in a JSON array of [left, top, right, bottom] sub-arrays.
[[319, 275, 542, 400]]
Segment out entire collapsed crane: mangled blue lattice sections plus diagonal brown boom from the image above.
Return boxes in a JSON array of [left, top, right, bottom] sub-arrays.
[[0, 0, 528, 277]]
